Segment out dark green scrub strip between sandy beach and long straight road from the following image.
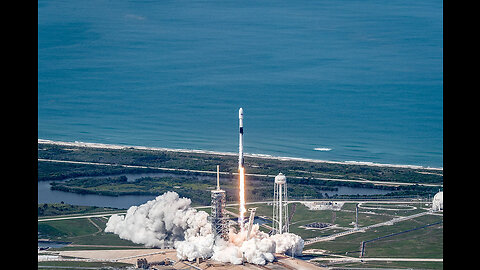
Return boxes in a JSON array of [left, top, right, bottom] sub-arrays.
[[38, 143, 443, 184]]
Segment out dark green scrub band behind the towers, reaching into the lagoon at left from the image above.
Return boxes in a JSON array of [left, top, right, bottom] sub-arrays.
[[43, 167, 438, 205]]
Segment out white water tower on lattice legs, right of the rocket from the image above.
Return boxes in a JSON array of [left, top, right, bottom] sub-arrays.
[[272, 173, 289, 234]]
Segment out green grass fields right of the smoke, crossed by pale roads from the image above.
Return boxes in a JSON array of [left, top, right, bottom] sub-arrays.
[[232, 202, 443, 269]]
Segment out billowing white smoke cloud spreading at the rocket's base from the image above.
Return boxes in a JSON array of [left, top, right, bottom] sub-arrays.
[[105, 192, 303, 265]]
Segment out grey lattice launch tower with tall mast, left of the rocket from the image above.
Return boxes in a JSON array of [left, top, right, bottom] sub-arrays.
[[210, 165, 228, 240]]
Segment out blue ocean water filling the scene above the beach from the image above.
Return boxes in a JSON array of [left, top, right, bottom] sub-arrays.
[[38, 0, 443, 167]]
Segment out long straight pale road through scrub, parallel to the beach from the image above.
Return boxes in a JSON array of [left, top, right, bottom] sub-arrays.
[[38, 158, 443, 187]]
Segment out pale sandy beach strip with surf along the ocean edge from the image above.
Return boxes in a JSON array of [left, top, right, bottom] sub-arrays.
[[38, 139, 443, 172]]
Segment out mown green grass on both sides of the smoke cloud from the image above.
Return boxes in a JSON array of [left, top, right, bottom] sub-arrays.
[[38, 199, 443, 269]]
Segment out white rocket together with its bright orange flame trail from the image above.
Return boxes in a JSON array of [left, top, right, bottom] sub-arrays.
[[238, 108, 247, 231]]
